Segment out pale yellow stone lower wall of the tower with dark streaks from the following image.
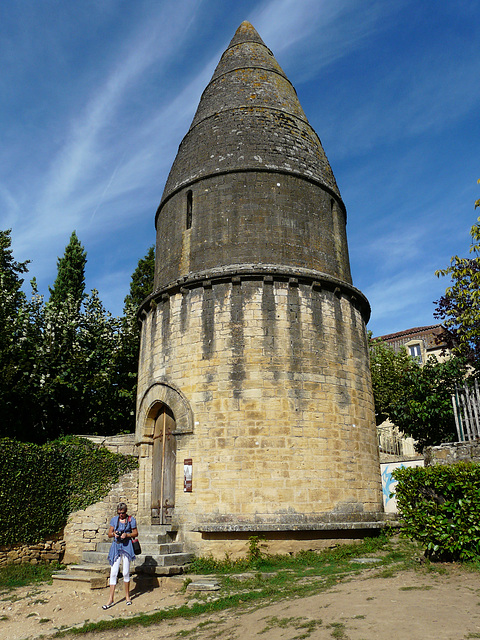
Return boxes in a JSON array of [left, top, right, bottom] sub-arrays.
[[137, 276, 382, 552]]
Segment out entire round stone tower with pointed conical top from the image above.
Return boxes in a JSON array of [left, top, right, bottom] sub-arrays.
[[136, 22, 382, 556]]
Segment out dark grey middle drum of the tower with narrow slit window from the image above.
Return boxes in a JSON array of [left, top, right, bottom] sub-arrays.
[[155, 171, 351, 288]]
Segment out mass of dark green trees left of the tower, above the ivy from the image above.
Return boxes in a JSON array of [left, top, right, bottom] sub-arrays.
[[0, 236, 153, 443]]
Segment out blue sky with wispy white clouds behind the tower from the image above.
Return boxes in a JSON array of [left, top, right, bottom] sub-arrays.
[[0, 0, 480, 335]]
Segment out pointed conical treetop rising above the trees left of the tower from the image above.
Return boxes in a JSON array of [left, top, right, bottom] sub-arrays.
[[49, 231, 87, 308]]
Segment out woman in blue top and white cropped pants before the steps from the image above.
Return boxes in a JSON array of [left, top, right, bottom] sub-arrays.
[[102, 502, 138, 609]]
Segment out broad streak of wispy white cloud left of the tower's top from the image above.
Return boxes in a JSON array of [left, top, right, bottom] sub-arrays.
[[10, 0, 199, 252]]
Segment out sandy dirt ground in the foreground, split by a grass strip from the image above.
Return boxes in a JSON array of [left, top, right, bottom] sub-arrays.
[[0, 565, 480, 640]]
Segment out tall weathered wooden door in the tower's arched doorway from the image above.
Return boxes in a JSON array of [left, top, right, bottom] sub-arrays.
[[152, 405, 177, 524]]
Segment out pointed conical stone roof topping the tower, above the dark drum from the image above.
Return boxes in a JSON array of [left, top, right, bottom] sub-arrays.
[[159, 22, 340, 210]]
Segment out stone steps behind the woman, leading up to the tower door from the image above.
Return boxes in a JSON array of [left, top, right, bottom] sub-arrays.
[[53, 525, 194, 589]]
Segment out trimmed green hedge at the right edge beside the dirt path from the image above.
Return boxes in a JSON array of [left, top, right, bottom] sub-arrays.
[[393, 462, 480, 560]]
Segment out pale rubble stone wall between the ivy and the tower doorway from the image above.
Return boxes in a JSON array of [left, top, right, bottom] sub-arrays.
[[63, 434, 138, 564]]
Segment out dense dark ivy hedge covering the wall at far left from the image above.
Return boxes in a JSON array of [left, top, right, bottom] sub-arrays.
[[0, 436, 137, 544]]
